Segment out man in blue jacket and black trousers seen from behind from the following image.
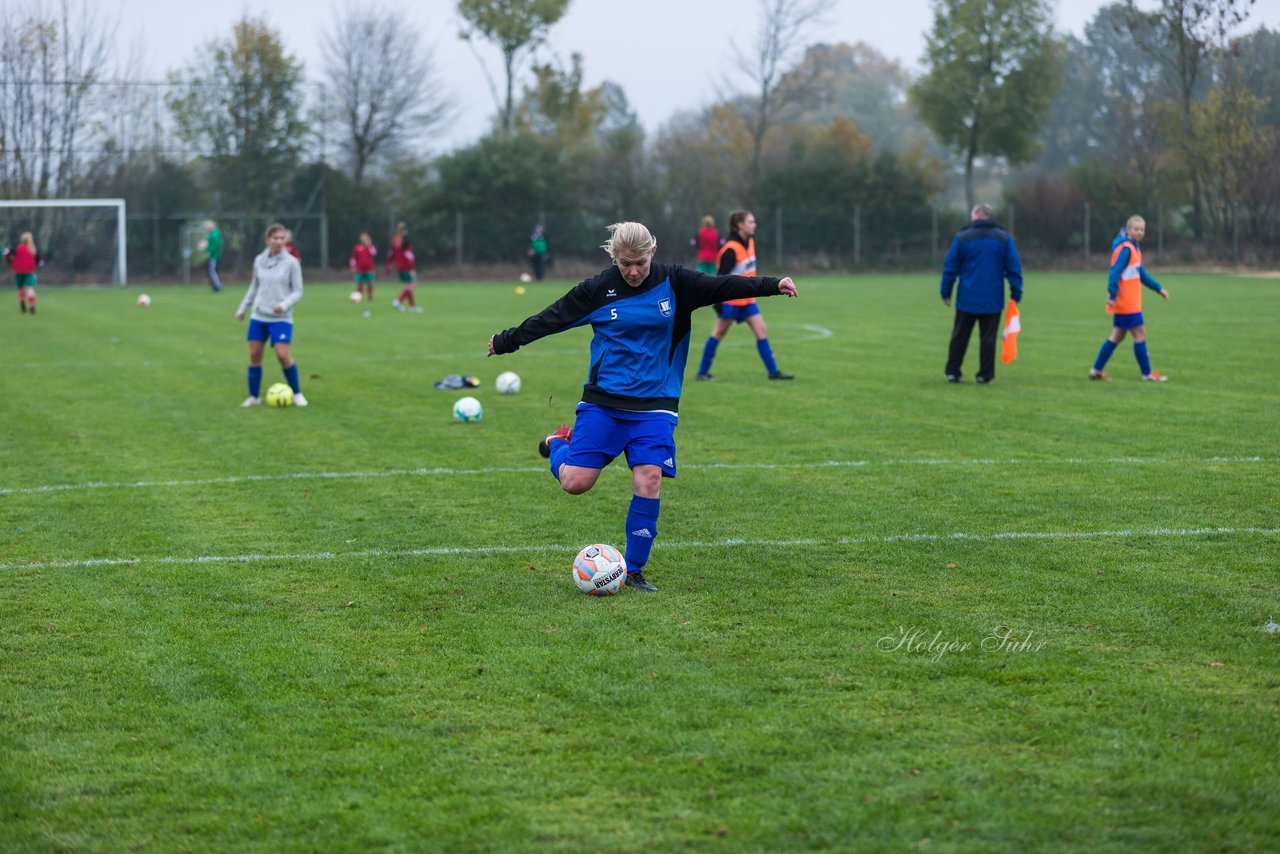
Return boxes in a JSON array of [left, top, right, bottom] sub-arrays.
[[942, 205, 1023, 384]]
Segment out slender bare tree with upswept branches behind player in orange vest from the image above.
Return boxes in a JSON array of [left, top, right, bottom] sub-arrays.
[[733, 0, 832, 193]]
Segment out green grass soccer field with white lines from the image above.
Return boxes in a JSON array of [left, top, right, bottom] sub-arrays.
[[0, 270, 1280, 851]]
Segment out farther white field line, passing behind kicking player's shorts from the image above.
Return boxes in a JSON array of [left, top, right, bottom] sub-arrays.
[[0, 457, 1271, 495]]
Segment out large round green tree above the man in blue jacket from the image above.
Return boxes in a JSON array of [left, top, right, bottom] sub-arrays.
[[910, 0, 1062, 207]]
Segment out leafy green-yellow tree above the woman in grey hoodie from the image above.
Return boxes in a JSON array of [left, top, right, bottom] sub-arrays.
[[166, 18, 308, 214]]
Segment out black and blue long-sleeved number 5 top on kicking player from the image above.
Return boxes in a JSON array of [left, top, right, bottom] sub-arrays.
[[493, 264, 781, 412]]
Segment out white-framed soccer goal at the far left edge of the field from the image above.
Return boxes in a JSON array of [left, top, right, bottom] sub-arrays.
[[0, 198, 128, 286]]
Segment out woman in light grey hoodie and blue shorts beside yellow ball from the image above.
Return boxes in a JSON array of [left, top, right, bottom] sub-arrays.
[[236, 223, 307, 406]]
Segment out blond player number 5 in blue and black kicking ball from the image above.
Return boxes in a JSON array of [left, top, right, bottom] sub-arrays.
[[489, 223, 796, 592]]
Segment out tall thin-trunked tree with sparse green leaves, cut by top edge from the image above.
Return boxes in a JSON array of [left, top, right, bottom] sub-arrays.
[[458, 0, 570, 134]]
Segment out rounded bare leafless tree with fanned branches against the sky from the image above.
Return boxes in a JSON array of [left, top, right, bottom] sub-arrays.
[[324, 3, 452, 184]]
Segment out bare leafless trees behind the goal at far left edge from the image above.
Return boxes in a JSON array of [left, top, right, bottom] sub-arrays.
[[0, 0, 115, 198]]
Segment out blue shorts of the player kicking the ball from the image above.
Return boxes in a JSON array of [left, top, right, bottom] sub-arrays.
[[564, 403, 676, 478]]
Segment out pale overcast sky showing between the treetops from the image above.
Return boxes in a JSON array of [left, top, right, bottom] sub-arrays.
[[110, 0, 1280, 151]]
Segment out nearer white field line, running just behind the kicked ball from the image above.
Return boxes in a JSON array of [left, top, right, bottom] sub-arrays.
[[0, 528, 1280, 570]]
